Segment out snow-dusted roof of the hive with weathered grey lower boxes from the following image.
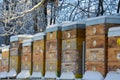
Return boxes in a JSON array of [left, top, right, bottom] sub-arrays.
[[61, 21, 85, 31]]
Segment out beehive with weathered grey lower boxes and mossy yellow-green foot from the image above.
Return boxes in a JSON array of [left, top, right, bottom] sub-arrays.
[[61, 22, 85, 77]]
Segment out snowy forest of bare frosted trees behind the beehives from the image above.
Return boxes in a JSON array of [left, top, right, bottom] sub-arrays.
[[0, 0, 120, 44]]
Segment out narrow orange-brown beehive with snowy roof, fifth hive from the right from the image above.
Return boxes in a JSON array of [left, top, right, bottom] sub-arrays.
[[32, 32, 45, 78]]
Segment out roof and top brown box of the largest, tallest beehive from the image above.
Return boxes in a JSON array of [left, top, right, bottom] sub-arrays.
[[86, 15, 120, 37]]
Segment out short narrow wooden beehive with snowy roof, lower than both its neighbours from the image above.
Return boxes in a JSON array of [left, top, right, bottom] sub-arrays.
[[21, 38, 33, 72]]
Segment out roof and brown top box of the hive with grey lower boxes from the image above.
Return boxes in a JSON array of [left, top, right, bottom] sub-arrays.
[[62, 22, 85, 40]]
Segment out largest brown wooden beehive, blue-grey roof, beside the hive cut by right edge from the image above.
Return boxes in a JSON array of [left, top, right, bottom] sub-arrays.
[[86, 15, 120, 76]]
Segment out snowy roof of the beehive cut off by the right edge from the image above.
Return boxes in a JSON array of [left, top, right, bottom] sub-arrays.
[[108, 27, 120, 37]]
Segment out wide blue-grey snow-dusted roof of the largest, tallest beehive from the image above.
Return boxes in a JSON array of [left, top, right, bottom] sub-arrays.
[[86, 15, 120, 26]]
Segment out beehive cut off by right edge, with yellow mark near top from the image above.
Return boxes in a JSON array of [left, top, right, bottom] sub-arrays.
[[108, 27, 120, 71]]
